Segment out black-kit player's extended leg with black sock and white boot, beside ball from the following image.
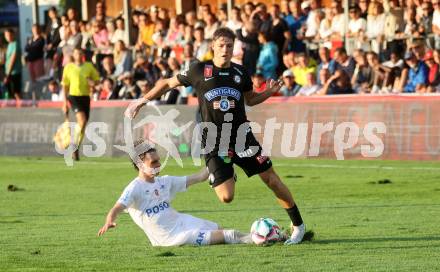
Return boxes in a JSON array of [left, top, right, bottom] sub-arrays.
[[260, 167, 306, 244]]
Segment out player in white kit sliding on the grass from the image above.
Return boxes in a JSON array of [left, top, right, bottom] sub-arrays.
[[98, 140, 252, 246]]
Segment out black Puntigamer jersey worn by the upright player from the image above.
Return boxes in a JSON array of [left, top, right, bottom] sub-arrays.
[[177, 61, 252, 153]]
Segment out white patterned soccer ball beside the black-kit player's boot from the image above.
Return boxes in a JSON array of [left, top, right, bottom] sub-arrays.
[[251, 218, 283, 245]]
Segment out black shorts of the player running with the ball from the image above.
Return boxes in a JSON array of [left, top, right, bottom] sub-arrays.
[[205, 132, 272, 188]]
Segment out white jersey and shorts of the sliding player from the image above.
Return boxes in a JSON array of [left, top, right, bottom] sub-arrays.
[[118, 176, 218, 246]]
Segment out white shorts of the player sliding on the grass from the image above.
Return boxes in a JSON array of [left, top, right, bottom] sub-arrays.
[[166, 214, 219, 246]]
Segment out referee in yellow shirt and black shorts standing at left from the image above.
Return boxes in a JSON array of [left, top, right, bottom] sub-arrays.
[[62, 49, 99, 160]]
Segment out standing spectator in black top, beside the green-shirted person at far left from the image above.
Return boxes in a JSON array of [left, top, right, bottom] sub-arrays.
[[25, 24, 44, 82]]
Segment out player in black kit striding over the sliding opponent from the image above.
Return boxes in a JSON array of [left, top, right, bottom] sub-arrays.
[[126, 28, 305, 244]]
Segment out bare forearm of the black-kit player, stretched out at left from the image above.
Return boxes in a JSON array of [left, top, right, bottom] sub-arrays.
[[125, 76, 182, 118]]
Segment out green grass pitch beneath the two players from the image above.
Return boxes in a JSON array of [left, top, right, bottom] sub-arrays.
[[0, 157, 440, 272]]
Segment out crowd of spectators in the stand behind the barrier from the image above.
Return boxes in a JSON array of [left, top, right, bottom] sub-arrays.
[[2, 0, 440, 104]]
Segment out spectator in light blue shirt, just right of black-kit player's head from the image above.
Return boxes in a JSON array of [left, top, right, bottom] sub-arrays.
[[257, 32, 278, 79]]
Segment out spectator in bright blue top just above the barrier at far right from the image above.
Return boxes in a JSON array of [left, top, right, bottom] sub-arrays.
[[403, 51, 429, 93]]
